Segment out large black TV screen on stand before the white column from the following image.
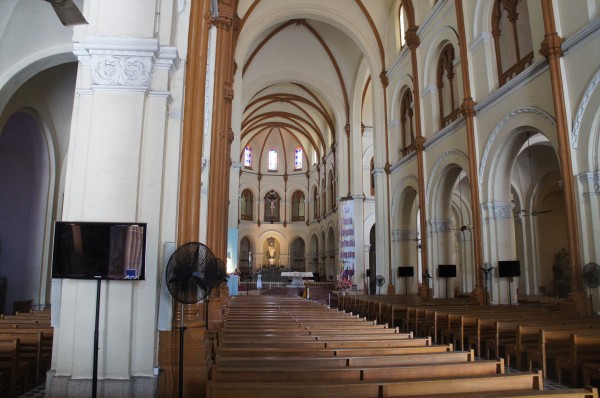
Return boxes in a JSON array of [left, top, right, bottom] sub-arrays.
[[52, 221, 146, 280]]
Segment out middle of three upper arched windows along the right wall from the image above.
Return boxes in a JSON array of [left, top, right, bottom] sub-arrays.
[[437, 44, 460, 129]]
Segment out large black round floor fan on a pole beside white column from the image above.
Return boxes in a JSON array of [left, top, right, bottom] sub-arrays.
[[165, 242, 217, 398]]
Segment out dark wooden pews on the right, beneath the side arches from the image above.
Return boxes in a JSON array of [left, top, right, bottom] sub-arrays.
[[339, 296, 600, 386]]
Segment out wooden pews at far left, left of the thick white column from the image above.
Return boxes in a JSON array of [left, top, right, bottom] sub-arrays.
[[0, 310, 53, 397]]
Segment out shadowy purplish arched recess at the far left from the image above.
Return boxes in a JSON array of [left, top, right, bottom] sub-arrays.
[[0, 112, 53, 312]]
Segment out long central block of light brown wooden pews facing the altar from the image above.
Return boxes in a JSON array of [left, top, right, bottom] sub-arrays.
[[207, 296, 598, 398]]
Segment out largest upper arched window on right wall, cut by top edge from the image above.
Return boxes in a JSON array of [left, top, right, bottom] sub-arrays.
[[492, 0, 533, 86]]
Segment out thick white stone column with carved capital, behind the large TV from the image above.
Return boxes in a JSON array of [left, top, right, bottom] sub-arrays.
[[46, 32, 178, 397]]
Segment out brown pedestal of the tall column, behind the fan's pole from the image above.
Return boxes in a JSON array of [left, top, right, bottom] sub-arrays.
[[158, 323, 212, 398]]
